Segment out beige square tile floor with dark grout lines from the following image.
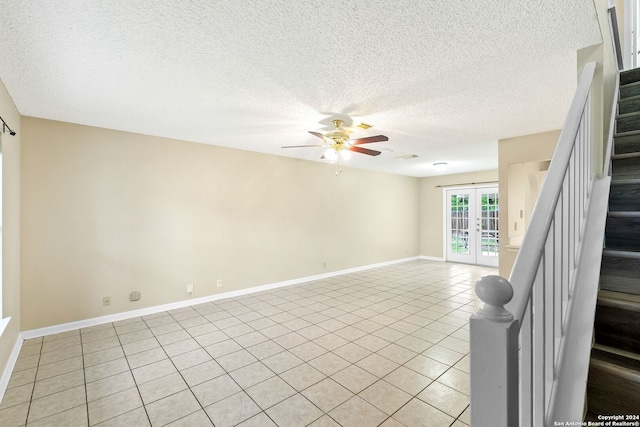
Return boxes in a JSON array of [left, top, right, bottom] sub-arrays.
[[0, 260, 496, 427]]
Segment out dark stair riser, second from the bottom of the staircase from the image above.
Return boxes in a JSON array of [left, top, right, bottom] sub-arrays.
[[595, 305, 640, 353]]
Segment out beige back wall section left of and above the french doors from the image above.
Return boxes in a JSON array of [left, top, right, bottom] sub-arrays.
[[420, 170, 502, 258]]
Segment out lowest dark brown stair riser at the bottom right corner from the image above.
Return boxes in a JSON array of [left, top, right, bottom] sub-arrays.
[[587, 363, 640, 415]]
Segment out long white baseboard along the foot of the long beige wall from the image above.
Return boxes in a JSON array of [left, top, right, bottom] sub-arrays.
[[22, 256, 424, 339]]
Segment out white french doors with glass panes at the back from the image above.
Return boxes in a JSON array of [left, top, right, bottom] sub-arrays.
[[445, 186, 499, 267]]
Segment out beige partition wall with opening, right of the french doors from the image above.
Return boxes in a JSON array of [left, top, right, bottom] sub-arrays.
[[498, 130, 560, 278]]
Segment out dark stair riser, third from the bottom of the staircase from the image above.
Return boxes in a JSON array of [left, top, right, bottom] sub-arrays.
[[600, 256, 640, 295]]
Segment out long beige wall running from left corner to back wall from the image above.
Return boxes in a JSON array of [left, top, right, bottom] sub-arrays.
[[22, 117, 419, 330]]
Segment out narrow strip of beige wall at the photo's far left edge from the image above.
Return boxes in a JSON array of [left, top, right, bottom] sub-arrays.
[[0, 78, 22, 374]]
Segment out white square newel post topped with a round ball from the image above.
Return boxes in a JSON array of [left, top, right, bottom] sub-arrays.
[[469, 276, 519, 427]]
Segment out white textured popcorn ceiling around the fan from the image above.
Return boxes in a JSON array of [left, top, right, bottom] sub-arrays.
[[0, 0, 601, 177]]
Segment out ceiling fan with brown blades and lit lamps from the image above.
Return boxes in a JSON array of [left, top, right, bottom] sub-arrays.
[[282, 119, 389, 160]]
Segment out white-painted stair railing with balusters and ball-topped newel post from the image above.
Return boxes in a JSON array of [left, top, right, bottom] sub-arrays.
[[470, 63, 608, 427]]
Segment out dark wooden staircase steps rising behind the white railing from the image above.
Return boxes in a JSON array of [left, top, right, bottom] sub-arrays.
[[587, 69, 640, 420]]
